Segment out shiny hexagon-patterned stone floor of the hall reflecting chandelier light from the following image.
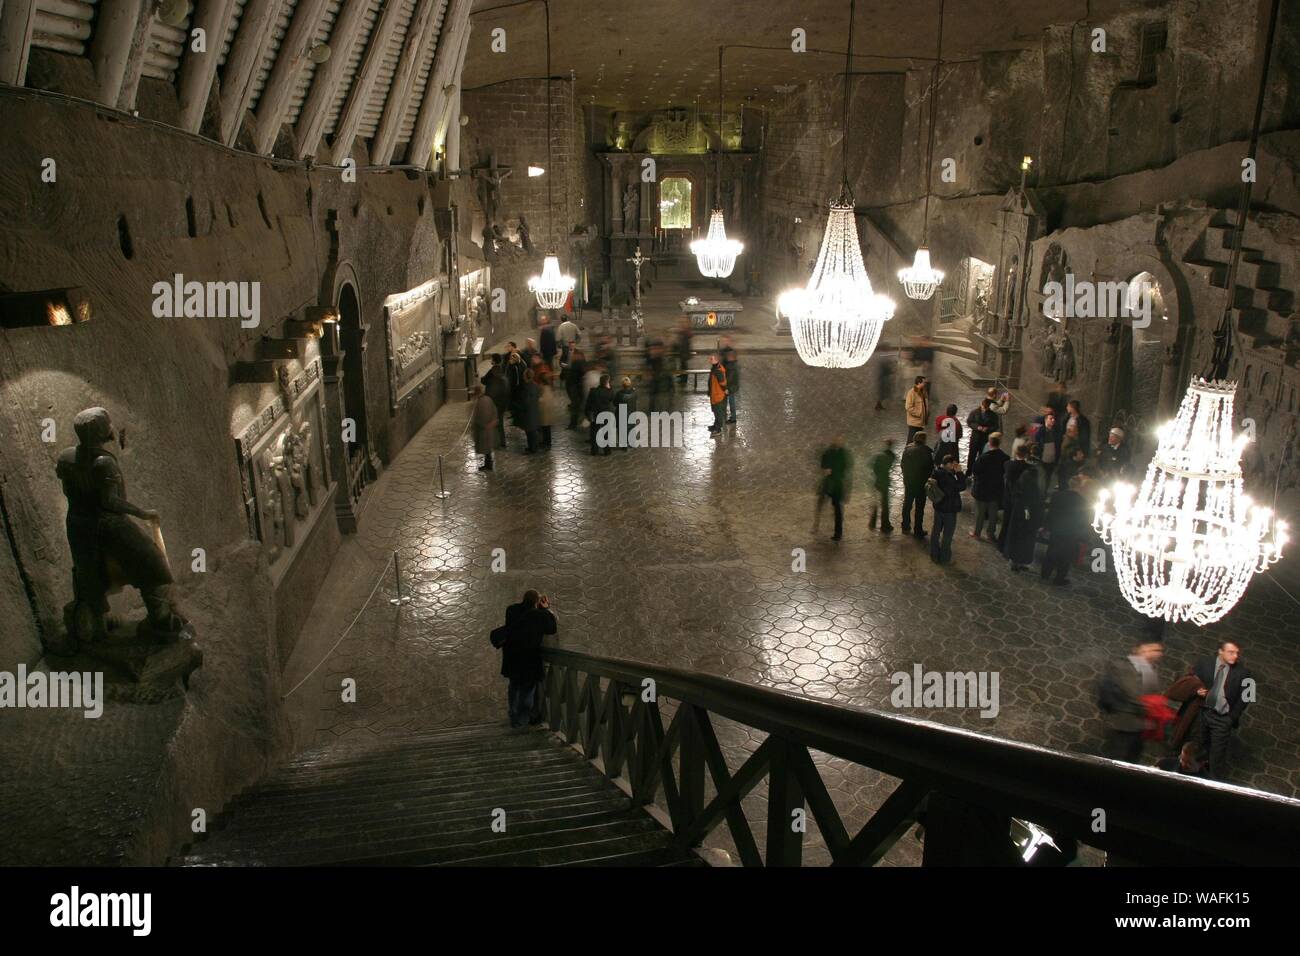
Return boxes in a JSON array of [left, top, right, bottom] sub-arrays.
[[286, 355, 1300, 862]]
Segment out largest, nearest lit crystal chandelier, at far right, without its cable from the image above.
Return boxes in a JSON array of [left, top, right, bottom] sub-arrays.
[[1093, 377, 1287, 626]]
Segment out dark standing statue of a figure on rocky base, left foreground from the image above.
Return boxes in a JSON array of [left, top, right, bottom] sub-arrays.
[[55, 407, 189, 644]]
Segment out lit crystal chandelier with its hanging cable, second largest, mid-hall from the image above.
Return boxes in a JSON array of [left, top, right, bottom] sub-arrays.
[[777, 0, 894, 368]]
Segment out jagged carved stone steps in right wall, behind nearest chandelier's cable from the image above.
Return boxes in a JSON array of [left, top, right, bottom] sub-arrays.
[[1183, 211, 1300, 364]]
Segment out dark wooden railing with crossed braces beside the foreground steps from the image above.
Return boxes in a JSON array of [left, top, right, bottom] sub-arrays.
[[543, 648, 1300, 865]]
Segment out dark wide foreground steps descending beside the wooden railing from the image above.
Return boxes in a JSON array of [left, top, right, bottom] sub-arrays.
[[173, 724, 707, 866]]
